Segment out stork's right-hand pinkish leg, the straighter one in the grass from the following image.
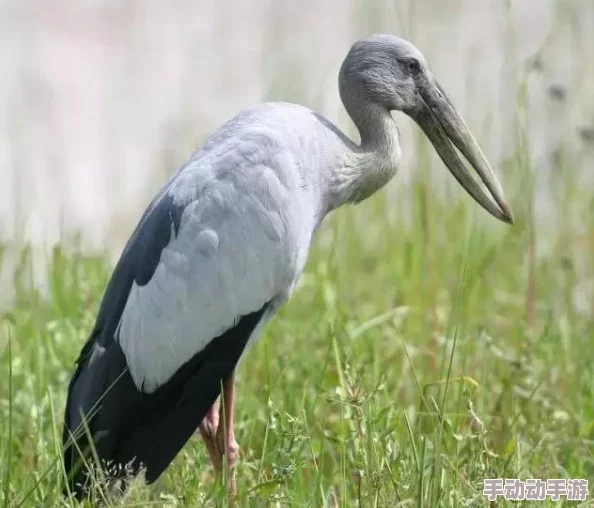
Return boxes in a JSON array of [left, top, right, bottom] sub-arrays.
[[217, 372, 239, 495]]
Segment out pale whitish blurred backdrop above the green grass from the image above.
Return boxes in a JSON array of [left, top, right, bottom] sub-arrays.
[[0, 0, 594, 298]]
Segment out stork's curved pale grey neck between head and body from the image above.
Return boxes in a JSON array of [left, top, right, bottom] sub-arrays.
[[334, 104, 400, 206]]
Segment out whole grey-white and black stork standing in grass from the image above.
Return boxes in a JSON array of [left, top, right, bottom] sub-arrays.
[[63, 34, 514, 498]]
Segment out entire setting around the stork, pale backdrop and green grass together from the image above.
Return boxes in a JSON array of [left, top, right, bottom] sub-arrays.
[[0, 0, 594, 508]]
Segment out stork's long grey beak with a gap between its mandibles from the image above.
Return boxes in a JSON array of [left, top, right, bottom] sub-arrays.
[[411, 77, 514, 224]]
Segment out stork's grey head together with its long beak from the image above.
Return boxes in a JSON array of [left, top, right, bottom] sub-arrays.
[[339, 35, 513, 223]]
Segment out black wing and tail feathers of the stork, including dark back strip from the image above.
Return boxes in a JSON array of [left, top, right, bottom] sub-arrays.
[[63, 185, 268, 498]]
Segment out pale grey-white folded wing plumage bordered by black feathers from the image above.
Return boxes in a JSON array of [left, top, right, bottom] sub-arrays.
[[118, 121, 316, 393]]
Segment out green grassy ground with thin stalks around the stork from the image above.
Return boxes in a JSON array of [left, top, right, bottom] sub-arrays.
[[0, 153, 594, 507]]
